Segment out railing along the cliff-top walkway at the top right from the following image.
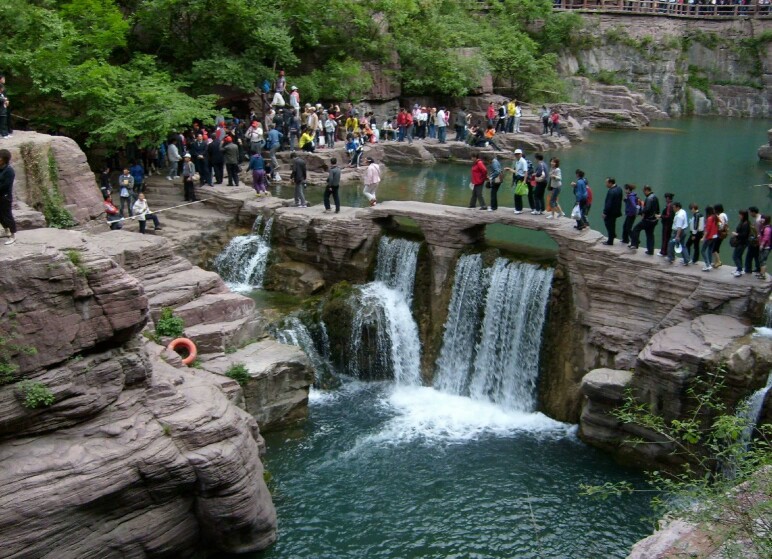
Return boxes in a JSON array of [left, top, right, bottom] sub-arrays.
[[552, 0, 772, 18]]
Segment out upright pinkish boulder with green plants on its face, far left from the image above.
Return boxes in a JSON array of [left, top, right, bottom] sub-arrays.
[[3, 132, 104, 229]]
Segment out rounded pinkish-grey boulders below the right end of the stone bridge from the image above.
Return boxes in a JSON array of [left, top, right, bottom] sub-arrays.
[[580, 314, 772, 465]]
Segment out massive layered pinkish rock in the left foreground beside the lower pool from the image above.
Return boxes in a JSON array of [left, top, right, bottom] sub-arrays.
[[0, 229, 276, 557]]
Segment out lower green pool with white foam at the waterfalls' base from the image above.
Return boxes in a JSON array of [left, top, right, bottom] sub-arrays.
[[242, 382, 651, 559]]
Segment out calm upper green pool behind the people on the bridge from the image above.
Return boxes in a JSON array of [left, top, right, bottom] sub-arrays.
[[268, 118, 772, 262]]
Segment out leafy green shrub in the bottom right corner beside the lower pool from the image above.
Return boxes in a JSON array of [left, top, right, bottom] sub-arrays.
[[582, 366, 772, 557]]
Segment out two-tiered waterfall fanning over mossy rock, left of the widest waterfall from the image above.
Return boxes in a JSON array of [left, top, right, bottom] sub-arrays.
[[346, 237, 421, 385]]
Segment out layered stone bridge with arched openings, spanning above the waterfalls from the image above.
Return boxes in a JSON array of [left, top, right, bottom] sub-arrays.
[[266, 202, 772, 421]]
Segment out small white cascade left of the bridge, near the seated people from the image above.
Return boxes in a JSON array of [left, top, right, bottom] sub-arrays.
[[214, 215, 273, 292]]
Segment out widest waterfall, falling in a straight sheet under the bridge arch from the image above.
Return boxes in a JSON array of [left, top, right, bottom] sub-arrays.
[[435, 256, 552, 412]]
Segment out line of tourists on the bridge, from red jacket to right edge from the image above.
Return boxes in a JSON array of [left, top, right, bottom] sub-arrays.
[[469, 149, 772, 280]]
